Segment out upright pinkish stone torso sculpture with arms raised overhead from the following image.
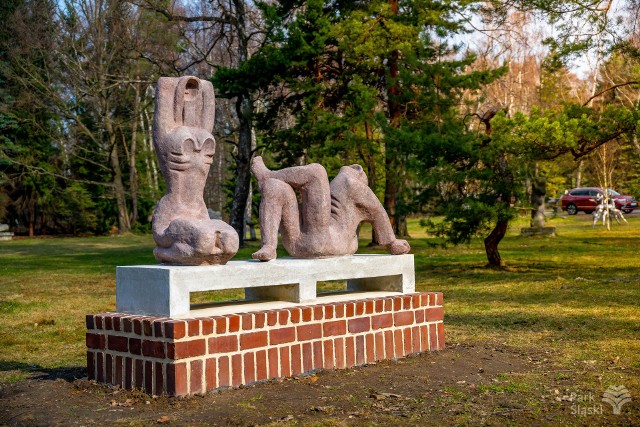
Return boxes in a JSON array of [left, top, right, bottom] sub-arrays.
[[153, 77, 238, 265]]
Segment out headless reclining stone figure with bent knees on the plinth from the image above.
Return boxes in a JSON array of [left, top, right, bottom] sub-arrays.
[[251, 157, 410, 261]]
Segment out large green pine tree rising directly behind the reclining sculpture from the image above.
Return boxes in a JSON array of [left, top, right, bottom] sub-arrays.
[[216, 0, 497, 247]]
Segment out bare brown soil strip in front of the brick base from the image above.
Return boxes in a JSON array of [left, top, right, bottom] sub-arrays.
[[0, 344, 640, 426]]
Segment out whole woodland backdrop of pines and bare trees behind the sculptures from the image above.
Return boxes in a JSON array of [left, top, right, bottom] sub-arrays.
[[0, 0, 640, 266]]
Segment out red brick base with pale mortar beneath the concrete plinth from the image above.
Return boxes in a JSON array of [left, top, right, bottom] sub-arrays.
[[87, 292, 444, 396]]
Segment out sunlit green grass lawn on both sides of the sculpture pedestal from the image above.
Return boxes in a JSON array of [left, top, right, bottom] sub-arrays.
[[0, 214, 640, 402]]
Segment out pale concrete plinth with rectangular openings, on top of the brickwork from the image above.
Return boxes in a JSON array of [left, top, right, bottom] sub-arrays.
[[116, 254, 415, 317]]
